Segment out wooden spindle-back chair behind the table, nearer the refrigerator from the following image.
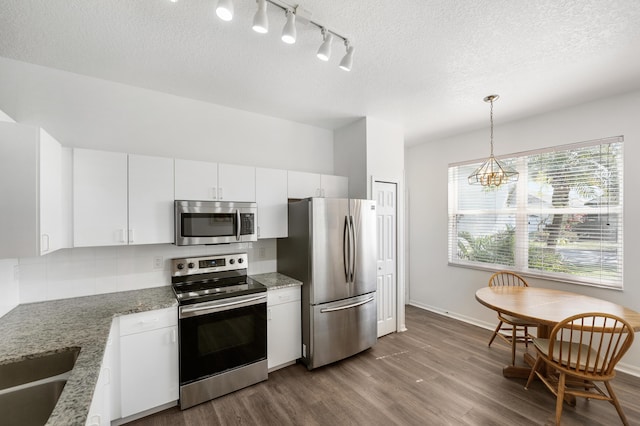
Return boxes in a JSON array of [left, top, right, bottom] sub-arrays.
[[489, 271, 537, 365]]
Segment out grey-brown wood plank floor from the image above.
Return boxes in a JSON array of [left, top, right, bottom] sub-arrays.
[[130, 306, 640, 426]]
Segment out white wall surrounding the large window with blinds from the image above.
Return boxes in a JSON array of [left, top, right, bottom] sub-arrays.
[[406, 92, 640, 375]]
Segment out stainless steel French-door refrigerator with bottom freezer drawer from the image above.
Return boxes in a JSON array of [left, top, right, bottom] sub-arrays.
[[278, 198, 377, 370]]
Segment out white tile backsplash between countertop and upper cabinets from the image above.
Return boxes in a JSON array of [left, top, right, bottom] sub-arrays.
[[16, 239, 277, 304]]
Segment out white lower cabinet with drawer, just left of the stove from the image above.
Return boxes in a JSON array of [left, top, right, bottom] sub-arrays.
[[120, 307, 178, 418]]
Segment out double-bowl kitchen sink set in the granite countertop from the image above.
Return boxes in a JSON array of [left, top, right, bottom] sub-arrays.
[[0, 348, 80, 426]]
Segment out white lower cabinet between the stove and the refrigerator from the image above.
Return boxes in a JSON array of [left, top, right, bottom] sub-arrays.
[[267, 286, 302, 371]]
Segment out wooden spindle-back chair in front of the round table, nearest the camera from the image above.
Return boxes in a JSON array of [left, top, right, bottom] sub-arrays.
[[525, 313, 634, 425]]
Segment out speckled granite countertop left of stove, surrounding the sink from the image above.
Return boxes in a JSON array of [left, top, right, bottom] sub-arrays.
[[0, 286, 178, 426]]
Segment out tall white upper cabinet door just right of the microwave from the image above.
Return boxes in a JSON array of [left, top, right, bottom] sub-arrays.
[[256, 168, 288, 238]]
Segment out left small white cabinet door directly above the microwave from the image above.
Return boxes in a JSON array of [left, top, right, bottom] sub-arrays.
[[174, 158, 218, 201]]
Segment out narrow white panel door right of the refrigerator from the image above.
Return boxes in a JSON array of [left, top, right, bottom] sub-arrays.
[[373, 182, 397, 337]]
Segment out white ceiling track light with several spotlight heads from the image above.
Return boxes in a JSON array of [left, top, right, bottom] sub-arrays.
[[211, 0, 354, 71]]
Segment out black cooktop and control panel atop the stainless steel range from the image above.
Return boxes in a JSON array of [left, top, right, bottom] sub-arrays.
[[171, 253, 267, 305]]
